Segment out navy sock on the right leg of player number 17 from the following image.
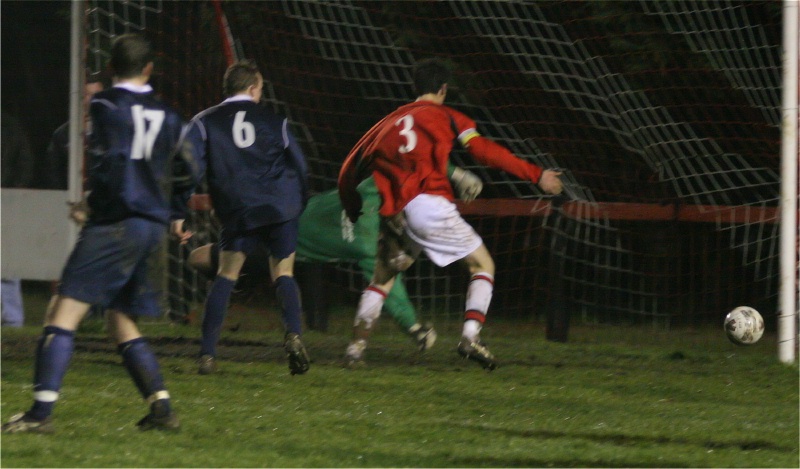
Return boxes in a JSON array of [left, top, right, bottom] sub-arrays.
[[117, 337, 169, 412]]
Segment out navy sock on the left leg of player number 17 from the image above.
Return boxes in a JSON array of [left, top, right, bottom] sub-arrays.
[[27, 326, 75, 420]]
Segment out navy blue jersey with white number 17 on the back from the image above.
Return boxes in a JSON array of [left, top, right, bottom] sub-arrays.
[[88, 84, 185, 224]]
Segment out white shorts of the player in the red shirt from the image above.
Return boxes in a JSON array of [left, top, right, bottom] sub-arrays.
[[403, 194, 483, 267]]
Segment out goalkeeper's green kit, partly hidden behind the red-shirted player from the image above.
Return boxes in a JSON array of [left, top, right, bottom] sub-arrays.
[[297, 177, 417, 330]]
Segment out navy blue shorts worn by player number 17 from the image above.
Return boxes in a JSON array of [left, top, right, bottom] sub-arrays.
[[58, 218, 166, 316]]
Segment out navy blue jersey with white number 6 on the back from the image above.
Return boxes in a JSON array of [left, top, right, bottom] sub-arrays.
[[184, 96, 307, 233]]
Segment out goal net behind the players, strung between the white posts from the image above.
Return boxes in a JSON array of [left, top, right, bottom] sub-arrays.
[[87, 0, 781, 327]]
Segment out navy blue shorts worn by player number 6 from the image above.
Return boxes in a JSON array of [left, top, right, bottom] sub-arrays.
[[219, 218, 299, 259]]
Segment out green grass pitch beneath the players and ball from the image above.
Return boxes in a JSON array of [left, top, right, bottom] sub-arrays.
[[2, 294, 800, 467]]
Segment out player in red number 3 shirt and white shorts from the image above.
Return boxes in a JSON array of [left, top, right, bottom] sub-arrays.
[[339, 59, 562, 370]]
